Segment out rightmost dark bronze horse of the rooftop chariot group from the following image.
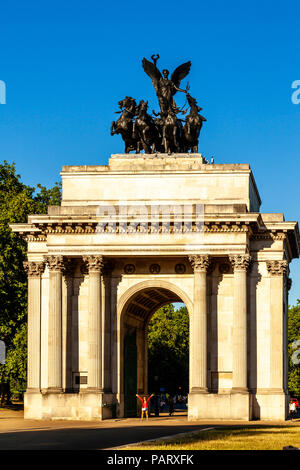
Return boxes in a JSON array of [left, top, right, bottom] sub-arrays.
[[182, 93, 206, 153]]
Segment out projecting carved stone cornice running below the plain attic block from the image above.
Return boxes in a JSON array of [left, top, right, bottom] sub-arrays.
[[10, 217, 300, 259]]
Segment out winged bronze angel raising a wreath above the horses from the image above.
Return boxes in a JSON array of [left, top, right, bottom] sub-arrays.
[[142, 54, 192, 114]]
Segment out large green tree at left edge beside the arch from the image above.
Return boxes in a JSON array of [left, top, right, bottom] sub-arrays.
[[0, 161, 61, 401]]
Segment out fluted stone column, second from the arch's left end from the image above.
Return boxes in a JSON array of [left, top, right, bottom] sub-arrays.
[[45, 255, 64, 393]]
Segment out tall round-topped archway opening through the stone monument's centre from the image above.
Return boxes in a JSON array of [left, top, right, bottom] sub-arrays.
[[123, 287, 189, 417]]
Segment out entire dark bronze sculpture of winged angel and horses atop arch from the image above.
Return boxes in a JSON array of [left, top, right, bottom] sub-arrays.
[[111, 54, 206, 153]]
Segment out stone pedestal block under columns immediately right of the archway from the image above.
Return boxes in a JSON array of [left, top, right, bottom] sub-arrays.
[[188, 392, 252, 421]]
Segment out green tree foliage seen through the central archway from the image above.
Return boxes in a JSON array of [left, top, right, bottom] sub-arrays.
[[148, 304, 189, 393]]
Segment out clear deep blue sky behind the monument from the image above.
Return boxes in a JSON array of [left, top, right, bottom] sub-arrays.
[[0, 0, 300, 303]]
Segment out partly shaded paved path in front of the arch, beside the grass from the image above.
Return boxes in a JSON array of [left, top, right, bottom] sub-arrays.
[[0, 411, 300, 450]]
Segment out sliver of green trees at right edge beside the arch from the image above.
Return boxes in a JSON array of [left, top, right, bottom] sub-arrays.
[[288, 299, 300, 396]]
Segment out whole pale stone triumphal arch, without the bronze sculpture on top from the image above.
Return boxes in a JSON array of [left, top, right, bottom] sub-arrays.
[[12, 154, 299, 420]]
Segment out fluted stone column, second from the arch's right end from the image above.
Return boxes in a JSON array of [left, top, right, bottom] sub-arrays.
[[229, 255, 250, 393]]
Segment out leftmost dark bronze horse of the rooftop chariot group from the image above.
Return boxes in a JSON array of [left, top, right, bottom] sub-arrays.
[[110, 96, 140, 153]]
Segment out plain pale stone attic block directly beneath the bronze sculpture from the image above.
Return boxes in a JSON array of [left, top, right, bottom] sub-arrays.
[[61, 154, 261, 211]]
